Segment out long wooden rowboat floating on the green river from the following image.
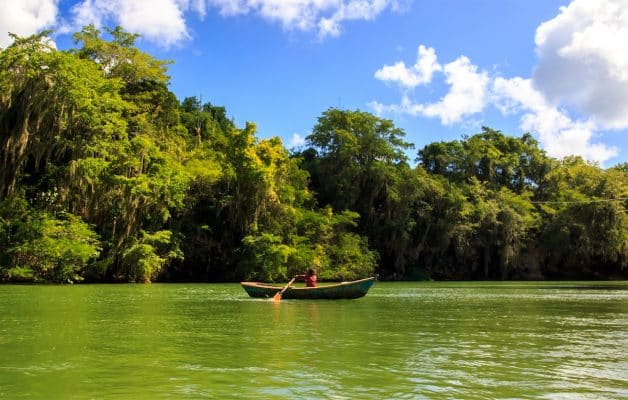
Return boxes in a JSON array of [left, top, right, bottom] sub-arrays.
[[240, 277, 375, 299]]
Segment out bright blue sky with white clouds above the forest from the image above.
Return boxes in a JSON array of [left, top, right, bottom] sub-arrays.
[[0, 0, 628, 167]]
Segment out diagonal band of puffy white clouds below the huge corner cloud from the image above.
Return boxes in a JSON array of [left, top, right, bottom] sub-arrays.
[[369, 47, 618, 163]]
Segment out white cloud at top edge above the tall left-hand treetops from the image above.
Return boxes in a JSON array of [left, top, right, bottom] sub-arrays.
[[67, 0, 189, 47]]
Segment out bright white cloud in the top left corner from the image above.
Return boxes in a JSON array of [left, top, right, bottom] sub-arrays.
[[0, 0, 58, 48]]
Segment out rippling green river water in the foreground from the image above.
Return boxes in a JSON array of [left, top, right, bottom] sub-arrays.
[[0, 282, 628, 399]]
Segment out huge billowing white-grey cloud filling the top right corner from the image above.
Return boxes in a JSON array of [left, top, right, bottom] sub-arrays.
[[534, 0, 628, 129]]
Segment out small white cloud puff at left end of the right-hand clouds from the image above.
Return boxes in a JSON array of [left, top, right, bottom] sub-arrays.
[[375, 45, 443, 89]]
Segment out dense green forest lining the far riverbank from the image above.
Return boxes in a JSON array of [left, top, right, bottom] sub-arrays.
[[0, 26, 628, 283]]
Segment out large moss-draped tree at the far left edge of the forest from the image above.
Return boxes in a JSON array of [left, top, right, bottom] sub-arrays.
[[0, 32, 125, 198]]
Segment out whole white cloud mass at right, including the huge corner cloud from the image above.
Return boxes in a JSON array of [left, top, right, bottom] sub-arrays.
[[370, 0, 628, 163]]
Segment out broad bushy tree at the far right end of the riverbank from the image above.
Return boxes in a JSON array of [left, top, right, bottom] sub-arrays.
[[538, 157, 628, 277]]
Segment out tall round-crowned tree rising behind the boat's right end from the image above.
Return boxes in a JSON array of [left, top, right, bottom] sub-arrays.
[[301, 108, 413, 278]]
